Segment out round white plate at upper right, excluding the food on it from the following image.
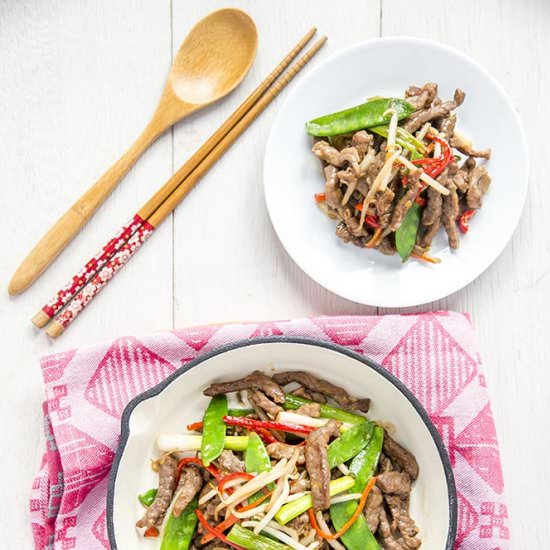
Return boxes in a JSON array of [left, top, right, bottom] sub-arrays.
[[264, 38, 528, 307]]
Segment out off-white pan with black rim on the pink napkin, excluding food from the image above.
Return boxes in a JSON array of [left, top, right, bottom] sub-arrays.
[[107, 338, 457, 550]]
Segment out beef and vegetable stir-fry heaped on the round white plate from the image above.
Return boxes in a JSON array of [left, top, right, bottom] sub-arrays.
[[306, 82, 491, 263]]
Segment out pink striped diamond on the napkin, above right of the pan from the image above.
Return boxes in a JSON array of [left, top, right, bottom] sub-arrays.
[[382, 316, 477, 415]]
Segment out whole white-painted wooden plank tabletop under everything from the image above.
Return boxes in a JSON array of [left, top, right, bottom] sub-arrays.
[[0, 0, 550, 550]]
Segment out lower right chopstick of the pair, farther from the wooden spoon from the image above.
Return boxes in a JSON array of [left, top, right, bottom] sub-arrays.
[[42, 37, 327, 338]]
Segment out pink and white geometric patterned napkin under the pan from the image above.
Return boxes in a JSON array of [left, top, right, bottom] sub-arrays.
[[30, 312, 510, 550]]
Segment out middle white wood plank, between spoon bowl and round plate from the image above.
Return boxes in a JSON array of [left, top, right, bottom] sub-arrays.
[[174, 0, 379, 326]]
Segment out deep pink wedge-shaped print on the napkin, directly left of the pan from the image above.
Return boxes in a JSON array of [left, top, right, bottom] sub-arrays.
[[55, 424, 115, 514]]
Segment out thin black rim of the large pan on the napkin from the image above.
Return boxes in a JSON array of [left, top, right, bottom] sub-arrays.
[[107, 336, 458, 550]]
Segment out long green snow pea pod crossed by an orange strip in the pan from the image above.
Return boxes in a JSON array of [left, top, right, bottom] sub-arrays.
[[330, 432, 384, 550]]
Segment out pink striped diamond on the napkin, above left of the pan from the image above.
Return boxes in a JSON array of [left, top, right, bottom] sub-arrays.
[[84, 336, 175, 418]]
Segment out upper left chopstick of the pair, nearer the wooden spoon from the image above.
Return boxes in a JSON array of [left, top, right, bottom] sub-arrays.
[[32, 27, 317, 328]]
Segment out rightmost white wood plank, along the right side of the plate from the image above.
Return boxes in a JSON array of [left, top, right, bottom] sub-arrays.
[[382, 0, 550, 548]]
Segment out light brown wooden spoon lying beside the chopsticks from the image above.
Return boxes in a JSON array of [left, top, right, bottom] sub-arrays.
[[8, 9, 258, 294]]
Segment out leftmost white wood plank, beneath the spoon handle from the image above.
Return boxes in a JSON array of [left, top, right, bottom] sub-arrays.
[[0, 0, 172, 548]]
